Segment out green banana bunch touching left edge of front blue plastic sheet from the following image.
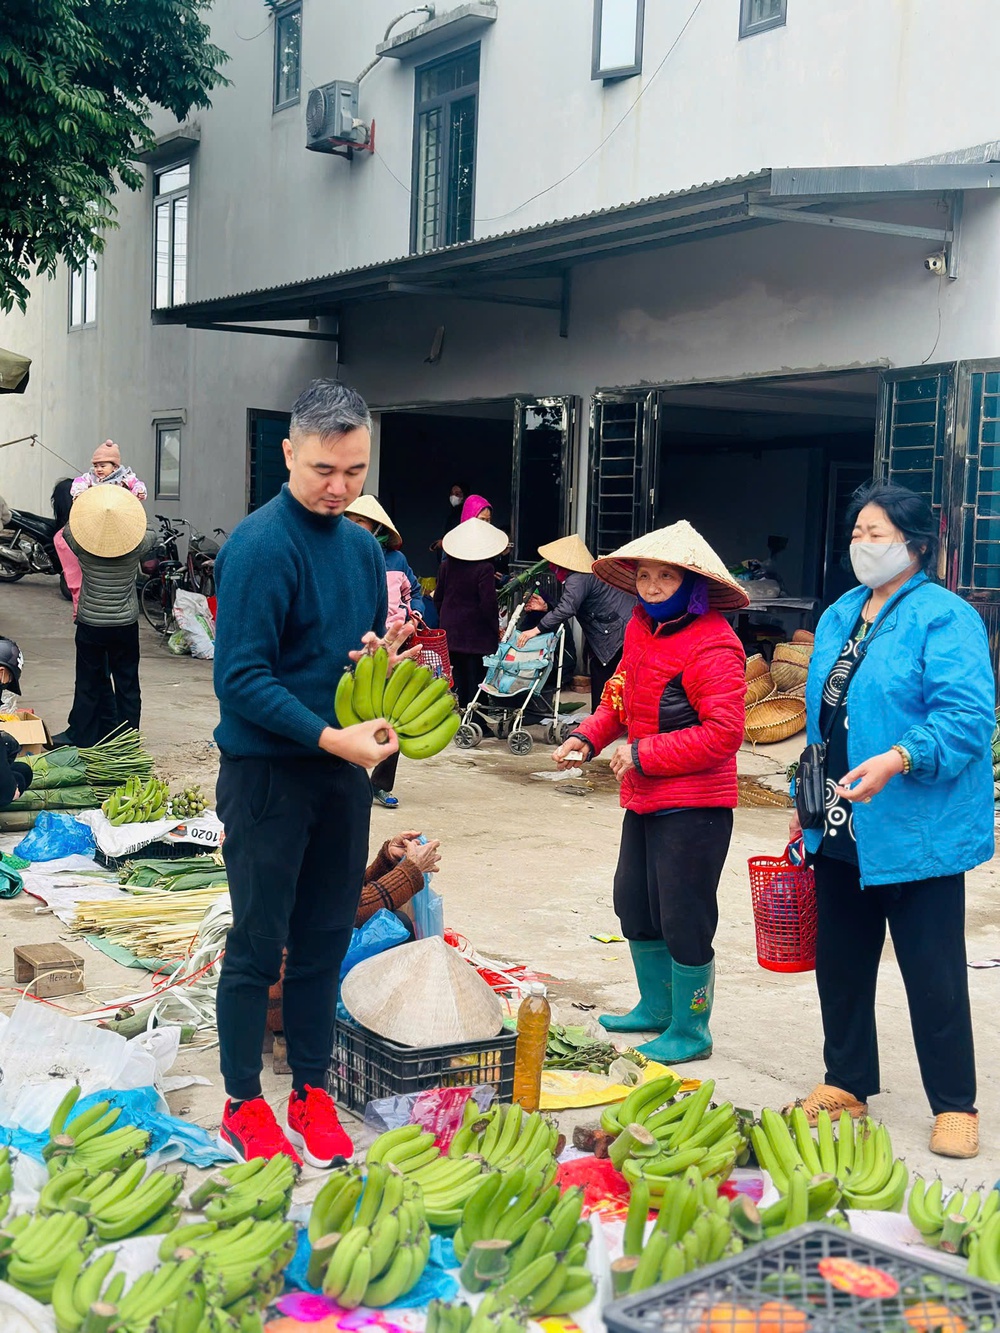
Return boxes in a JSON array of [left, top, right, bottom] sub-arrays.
[[160, 1217, 296, 1326]]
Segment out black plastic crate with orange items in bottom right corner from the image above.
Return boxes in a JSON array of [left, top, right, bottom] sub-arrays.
[[604, 1225, 1000, 1333]]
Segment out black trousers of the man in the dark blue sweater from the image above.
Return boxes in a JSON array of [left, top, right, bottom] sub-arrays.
[[216, 754, 372, 1101]]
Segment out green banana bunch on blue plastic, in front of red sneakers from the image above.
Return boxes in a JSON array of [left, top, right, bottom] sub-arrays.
[[307, 1161, 431, 1309]]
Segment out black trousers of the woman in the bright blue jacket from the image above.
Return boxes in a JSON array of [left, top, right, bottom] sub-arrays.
[[813, 856, 976, 1116]]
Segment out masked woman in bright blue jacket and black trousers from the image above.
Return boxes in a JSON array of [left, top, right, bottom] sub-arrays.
[[792, 484, 995, 1157]]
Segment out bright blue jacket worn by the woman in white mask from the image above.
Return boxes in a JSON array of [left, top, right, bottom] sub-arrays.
[[805, 573, 995, 884]]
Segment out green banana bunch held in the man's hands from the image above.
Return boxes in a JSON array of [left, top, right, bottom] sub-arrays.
[[333, 648, 461, 758]]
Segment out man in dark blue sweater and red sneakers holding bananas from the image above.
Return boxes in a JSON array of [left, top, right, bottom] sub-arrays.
[[215, 380, 413, 1166]]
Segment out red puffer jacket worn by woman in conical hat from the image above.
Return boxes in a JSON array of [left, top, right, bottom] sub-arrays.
[[576, 607, 747, 814]]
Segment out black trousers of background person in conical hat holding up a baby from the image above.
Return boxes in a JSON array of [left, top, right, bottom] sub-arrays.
[[68, 621, 143, 749]]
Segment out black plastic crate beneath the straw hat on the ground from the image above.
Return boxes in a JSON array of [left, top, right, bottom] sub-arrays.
[[329, 1020, 517, 1112]]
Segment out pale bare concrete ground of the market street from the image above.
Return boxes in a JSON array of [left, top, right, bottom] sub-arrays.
[[0, 579, 1000, 1184]]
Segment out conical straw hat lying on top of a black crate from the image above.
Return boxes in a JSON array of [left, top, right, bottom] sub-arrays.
[[340, 938, 503, 1046]]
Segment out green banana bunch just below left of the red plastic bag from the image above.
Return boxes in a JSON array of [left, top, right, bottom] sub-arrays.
[[453, 1157, 595, 1317]]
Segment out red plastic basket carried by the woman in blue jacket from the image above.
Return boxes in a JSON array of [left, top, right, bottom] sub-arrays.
[[748, 856, 816, 972]]
